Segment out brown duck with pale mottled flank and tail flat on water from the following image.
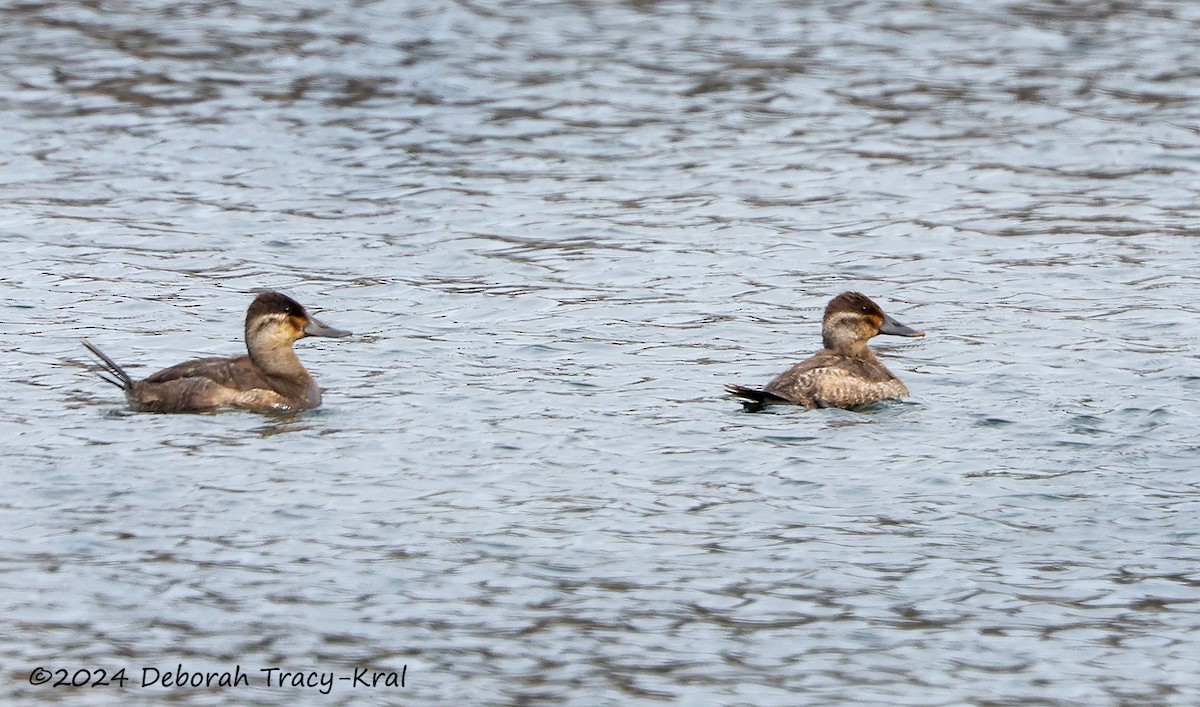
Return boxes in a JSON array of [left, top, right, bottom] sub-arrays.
[[725, 292, 925, 412]]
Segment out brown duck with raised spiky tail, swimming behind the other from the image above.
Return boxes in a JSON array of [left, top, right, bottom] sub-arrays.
[[83, 292, 350, 413]]
